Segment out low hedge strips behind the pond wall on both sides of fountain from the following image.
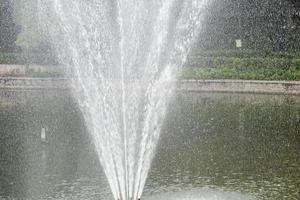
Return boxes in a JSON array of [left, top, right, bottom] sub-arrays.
[[0, 50, 300, 80]]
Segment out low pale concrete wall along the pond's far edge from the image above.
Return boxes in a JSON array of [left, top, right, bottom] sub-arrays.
[[0, 77, 300, 95]]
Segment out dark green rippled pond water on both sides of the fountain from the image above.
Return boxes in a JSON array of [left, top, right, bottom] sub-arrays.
[[0, 91, 300, 200]]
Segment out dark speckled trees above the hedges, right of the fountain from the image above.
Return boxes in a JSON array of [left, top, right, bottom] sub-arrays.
[[198, 0, 300, 51]]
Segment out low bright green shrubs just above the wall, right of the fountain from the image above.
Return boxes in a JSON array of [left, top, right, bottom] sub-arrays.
[[179, 54, 300, 80]]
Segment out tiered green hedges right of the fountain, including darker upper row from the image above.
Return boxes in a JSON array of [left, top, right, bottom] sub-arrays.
[[179, 51, 300, 80]]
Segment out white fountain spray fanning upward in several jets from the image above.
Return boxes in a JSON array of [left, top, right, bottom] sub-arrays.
[[18, 0, 208, 200]]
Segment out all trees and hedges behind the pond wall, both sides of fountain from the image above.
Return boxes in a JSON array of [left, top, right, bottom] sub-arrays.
[[0, 0, 300, 80]]
